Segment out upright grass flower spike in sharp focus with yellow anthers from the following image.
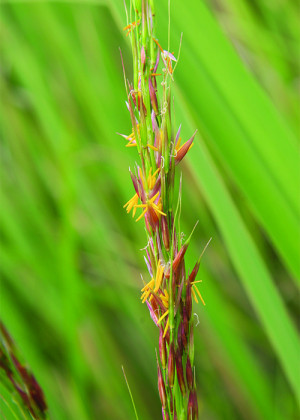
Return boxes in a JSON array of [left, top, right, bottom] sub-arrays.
[[121, 0, 205, 420]]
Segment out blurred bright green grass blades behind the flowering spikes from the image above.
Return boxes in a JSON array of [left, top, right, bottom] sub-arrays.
[[0, 0, 300, 420]]
